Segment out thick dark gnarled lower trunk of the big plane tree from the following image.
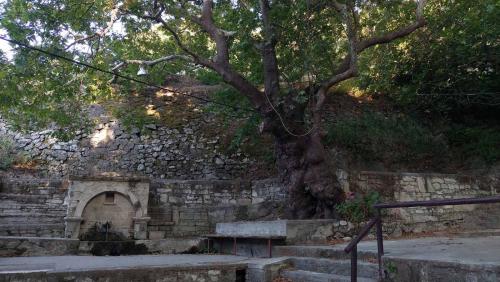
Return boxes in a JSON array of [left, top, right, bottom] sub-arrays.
[[276, 131, 344, 219]]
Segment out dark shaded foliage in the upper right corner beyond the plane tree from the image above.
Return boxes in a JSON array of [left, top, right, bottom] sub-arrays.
[[359, 0, 500, 114]]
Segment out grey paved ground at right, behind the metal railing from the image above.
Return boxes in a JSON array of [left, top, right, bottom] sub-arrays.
[[334, 236, 500, 266]]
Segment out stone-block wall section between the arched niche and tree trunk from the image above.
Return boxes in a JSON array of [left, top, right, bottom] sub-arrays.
[[148, 179, 286, 239]]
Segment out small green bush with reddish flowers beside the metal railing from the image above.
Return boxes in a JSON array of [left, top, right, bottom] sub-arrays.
[[336, 191, 380, 223]]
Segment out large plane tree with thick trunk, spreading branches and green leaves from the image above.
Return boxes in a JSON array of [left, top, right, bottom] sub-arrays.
[[0, 0, 426, 218]]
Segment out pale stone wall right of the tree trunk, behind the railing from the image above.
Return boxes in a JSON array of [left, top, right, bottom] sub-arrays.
[[349, 171, 500, 234]]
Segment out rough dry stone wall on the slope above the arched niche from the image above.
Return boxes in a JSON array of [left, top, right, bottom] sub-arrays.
[[0, 106, 258, 179]]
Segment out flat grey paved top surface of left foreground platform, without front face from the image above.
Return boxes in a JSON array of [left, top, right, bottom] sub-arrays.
[[0, 255, 247, 273]]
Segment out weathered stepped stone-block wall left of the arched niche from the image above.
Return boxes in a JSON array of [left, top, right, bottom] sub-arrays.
[[0, 178, 66, 237]]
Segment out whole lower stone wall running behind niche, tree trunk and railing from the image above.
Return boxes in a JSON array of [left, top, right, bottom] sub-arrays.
[[0, 172, 500, 240]]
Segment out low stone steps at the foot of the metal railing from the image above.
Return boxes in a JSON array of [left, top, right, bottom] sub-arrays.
[[274, 246, 378, 282]]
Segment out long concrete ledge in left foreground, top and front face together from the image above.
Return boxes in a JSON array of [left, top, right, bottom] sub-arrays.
[[0, 255, 247, 282]]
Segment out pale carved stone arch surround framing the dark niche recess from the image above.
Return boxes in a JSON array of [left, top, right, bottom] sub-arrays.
[[65, 177, 150, 239]]
